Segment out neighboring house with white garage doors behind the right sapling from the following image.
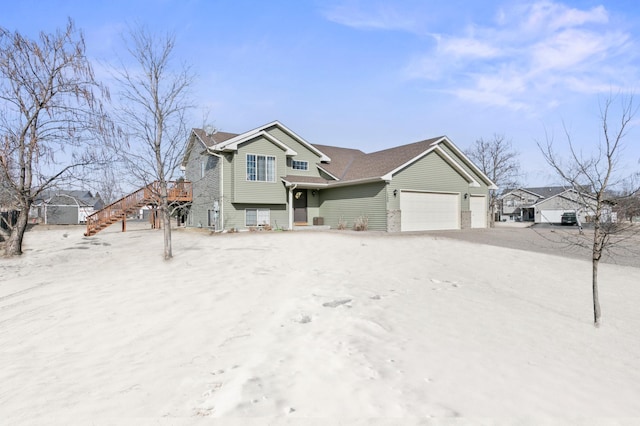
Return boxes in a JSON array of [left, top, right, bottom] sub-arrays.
[[499, 186, 612, 224]]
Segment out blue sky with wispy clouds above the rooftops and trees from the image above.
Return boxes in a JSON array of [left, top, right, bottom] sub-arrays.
[[0, 0, 640, 186]]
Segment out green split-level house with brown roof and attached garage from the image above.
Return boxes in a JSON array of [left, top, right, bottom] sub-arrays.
[[183, 121, 496, 232]]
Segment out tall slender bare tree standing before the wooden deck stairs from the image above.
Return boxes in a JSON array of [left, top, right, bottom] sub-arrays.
[[114, 27, 194, 260]]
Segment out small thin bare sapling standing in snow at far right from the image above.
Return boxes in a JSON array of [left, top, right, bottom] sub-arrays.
[[538, 96, 637, 327]]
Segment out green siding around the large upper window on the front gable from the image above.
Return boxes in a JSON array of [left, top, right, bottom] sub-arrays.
[[233, 137, 287, 204]]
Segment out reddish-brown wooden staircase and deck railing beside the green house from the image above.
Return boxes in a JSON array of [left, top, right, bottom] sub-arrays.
[[84, 181, 193, 237]]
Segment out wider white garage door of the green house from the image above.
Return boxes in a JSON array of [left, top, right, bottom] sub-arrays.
[[400, 191, 460, 231]]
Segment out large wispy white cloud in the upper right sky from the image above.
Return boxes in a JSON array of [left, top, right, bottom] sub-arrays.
[[405, 0, 639, 110]]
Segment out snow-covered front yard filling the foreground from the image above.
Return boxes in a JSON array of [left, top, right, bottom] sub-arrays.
[[0, 225, 640, 424]]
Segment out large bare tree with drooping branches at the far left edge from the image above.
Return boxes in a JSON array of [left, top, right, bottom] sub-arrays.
[[0, 20, 109, 256]]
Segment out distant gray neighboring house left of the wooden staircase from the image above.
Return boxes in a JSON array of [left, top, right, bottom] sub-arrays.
[[29, 190, 104, 225]]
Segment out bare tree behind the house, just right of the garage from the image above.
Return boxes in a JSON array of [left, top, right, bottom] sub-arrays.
[[465, 134, 520, 225]]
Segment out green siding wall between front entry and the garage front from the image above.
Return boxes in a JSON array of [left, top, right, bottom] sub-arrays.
[[318, 182, 387, 231]]
